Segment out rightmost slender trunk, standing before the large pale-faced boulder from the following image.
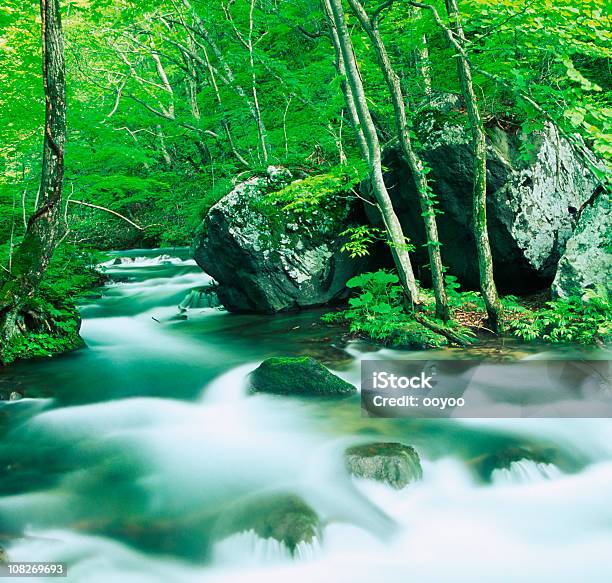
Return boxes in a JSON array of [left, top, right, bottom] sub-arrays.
[[445, 0, 502, 332]]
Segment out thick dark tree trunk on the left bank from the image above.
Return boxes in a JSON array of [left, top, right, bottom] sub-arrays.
[[0, 0, 66, 361]]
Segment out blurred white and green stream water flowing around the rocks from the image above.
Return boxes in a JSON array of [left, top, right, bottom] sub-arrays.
[[0, 250, 612, 583]]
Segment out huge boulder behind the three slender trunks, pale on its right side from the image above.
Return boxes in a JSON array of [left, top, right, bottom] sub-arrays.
[[378, 97, 598, 292]]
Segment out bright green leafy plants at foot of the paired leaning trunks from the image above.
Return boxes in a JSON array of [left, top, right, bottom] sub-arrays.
[[323, 271, 447, 348]]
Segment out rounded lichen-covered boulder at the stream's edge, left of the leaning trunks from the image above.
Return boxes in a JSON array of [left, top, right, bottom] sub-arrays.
[[192, 168, 358, 313]]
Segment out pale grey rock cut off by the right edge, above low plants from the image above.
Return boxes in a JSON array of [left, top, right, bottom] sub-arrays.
[[552, 195, 612, 298]]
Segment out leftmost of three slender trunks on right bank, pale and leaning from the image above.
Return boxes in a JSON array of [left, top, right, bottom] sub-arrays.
[[322, 0, 421, 306]]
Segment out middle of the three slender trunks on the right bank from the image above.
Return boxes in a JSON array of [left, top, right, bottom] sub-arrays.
[[348, 0, 449, 321]]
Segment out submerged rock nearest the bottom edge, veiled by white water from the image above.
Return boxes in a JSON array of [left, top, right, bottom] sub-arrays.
[[215, 493, 321, 553]]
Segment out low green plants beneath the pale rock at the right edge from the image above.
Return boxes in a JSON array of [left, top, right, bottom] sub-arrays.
[[508, 292, 612, 344]]
